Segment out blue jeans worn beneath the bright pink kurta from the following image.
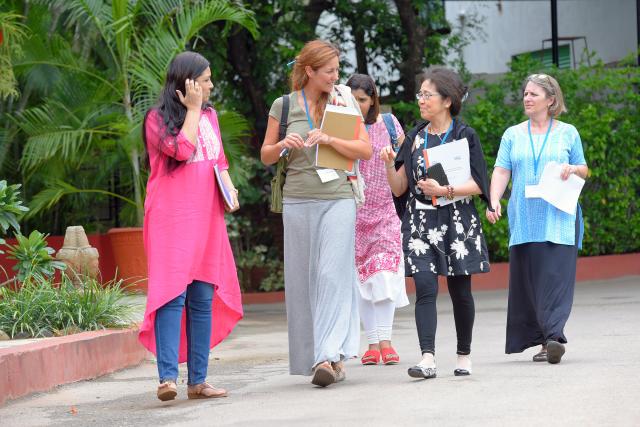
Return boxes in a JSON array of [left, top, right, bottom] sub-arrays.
[[155, 280, 213, 385]]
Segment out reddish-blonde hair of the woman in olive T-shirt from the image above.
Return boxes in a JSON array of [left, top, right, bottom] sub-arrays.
[[290, 40, 340, 122]]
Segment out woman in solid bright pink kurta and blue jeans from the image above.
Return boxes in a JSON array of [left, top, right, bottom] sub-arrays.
[[139, 52, 242, 400]]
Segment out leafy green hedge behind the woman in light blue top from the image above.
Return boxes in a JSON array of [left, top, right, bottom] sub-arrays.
[[464, 56, 640, 261]]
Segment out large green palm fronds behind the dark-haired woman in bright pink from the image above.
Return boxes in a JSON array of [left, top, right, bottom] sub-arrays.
[[0, 0, 257, 229]]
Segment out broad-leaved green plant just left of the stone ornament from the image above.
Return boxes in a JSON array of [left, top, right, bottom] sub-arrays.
[[6, 230, 66, 283]]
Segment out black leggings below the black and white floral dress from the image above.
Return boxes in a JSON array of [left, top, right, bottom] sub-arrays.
[[413, 272, 476, 354]]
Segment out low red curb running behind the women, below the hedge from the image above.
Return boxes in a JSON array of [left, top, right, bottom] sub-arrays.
[[242, 253, 640, 304]]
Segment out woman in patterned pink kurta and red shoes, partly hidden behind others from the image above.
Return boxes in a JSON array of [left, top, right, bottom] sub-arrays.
[[347, 74, 409, 365]]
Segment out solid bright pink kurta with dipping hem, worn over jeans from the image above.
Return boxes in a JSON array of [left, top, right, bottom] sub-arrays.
[[139, 108, 243, 362]]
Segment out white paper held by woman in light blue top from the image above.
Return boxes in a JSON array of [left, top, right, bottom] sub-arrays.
[[525, 162, 584, 215]]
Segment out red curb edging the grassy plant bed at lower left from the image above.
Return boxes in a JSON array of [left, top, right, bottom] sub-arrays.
[[0, 328, 147, 405]]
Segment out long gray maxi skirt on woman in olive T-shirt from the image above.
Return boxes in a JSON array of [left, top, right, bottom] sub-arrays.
[[282, 198, 360, 375]]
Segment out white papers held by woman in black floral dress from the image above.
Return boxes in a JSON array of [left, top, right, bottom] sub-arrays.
[[427, 138, 471, 206]]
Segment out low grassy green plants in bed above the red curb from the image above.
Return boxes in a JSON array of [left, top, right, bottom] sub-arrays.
[[0, 274, 138, 337]]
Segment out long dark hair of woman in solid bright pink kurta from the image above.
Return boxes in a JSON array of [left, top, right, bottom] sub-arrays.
[[142, 52, 209, 172]]
